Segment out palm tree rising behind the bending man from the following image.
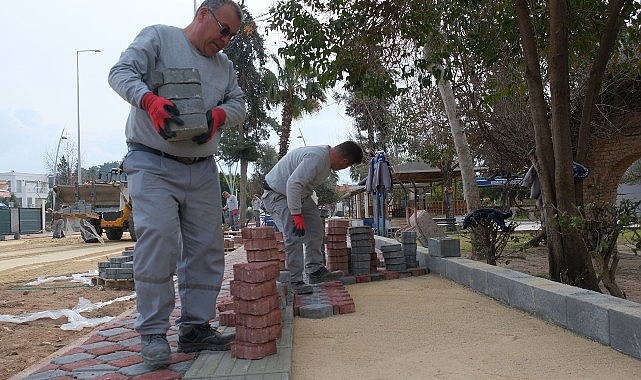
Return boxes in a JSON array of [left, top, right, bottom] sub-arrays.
[[265, 55, 327, 159]]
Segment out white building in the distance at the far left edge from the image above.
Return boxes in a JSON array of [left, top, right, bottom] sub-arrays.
[[0, 170, 51, 208]]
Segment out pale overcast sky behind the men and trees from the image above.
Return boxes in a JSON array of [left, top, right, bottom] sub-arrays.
[[0, 0, 352, 182]]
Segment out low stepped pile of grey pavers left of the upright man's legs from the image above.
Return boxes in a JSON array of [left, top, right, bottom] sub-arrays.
[[91, 247, 134, 290]]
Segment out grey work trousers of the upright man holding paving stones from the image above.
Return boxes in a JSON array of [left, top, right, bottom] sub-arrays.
[[123, 151, 225, 335]]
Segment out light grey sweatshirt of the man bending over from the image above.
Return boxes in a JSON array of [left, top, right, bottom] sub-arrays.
[[265, 145, 332, 214]]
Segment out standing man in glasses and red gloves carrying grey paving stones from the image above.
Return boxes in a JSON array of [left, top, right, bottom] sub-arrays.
[[109, 0, 246, 368]]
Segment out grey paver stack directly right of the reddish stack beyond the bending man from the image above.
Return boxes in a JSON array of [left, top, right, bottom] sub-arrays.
[[349, 226, 378, 276]]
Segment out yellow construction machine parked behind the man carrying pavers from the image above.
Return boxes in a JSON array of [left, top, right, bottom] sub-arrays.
[[53, 168, 137, 243]]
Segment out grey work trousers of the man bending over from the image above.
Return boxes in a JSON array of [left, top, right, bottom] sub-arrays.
[[262, 190, 325, 282]]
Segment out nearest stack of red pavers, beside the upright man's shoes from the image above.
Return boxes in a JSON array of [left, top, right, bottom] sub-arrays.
[[230, 261, 282, 360]]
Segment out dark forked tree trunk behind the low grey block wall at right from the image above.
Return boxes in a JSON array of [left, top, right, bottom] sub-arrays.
[[515, 0, 599, 291]]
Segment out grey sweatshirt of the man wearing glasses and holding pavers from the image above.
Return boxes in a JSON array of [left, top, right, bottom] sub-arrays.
[[109, 25, 246, 157]]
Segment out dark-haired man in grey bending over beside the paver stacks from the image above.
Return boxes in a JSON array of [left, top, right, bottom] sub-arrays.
[[263, 141, 363, 294]]
